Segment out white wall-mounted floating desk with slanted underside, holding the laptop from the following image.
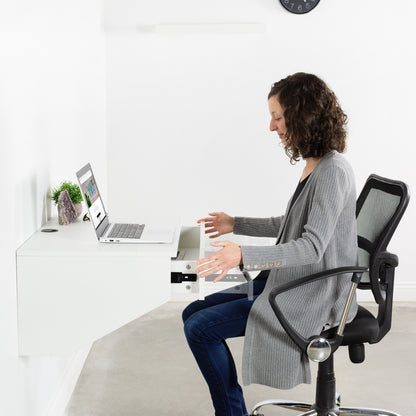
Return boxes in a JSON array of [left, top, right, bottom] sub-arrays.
[[16, 216, 180, 355]]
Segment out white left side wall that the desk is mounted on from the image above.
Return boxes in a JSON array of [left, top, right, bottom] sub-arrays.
[[0, 0, 107, 415]]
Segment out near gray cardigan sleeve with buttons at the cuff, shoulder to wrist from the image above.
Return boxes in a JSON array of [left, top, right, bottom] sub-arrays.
[[241, 165, 355, 270]]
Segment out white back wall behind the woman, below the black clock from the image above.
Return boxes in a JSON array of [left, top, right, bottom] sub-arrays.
[[105, 0, 416, 300]]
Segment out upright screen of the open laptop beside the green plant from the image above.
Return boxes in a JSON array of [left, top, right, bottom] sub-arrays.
[[77, 165, 106, 229]]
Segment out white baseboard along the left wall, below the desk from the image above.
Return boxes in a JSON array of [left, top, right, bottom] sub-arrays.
[[44, 345, 92, 416]]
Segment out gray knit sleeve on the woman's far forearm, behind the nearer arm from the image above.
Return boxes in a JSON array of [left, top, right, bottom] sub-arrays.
[[233, 215, 283, 237]]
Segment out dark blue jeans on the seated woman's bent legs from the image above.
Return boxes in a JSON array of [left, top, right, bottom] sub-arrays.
[[182, 280, 266, 416]]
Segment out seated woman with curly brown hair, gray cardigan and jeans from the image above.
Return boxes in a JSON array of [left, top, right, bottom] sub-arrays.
[[183, 73, 357, 416]]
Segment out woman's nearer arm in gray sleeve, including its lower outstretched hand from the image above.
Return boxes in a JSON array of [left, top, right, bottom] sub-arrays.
[[196, 166, 355, 280]]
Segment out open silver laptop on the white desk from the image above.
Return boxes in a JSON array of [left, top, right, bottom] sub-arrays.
[[76, 163, 174, 244]]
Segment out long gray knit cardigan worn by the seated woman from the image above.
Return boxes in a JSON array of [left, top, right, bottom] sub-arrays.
[[233, 151, 357, 389]]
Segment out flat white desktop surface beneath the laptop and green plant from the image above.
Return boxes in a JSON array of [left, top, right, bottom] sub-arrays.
[[17, 218, 181, 257]]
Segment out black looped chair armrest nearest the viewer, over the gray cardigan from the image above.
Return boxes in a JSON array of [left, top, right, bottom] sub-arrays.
[[269, 266, 368, 352]]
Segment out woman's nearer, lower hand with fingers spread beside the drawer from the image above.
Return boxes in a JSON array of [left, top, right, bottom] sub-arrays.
[[196, 241, 242, 283]]
